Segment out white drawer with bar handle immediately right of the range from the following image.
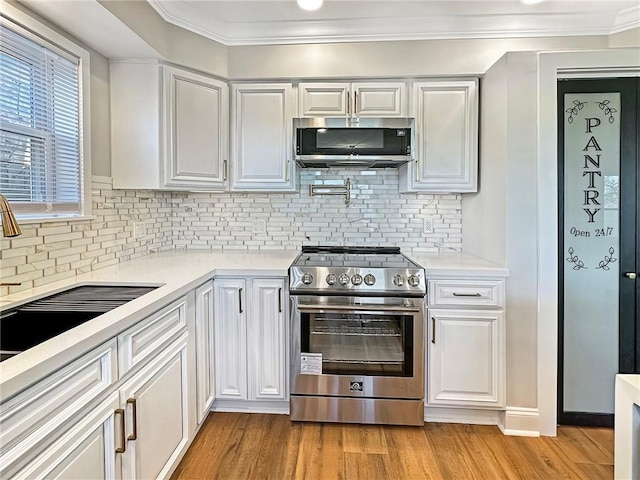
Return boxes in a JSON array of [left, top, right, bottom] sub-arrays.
[[428, 279, 504, 307]]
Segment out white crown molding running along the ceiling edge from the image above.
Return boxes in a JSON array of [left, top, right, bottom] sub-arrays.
[[148, 0, 640, 46]]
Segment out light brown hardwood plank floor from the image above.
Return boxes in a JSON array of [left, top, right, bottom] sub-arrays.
[[172, 412, 613, 480]]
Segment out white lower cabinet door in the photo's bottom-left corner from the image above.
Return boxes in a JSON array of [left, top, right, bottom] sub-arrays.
[[6, 392, 121, 480]]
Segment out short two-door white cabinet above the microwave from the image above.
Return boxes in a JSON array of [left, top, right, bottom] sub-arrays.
[[298, 81, 407, 117]]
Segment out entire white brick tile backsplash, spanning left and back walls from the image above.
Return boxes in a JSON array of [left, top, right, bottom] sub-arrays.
[[0, 169, 462, 295]]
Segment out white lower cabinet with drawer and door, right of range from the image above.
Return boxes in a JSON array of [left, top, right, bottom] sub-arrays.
[[425, 277, 506, 409]]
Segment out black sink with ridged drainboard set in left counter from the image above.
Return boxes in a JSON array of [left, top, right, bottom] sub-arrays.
[[0, 285, 158, 361]]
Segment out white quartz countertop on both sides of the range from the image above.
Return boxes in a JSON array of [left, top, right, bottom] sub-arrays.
[[0, 250, 507, 399]]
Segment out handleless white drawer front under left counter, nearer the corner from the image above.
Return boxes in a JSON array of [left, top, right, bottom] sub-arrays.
[[118, 298, 187, 378]]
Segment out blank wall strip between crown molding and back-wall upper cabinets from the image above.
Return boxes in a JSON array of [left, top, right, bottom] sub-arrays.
[[229, 36, 608, 79]]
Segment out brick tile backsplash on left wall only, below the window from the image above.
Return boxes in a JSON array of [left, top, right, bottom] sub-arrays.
[[0, 177, 173, 295]]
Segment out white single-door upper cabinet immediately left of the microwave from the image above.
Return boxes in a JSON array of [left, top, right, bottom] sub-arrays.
[[231, 83, 296, 192]]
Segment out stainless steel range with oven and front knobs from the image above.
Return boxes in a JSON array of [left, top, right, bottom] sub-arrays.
[[289, 246, 426, 425]]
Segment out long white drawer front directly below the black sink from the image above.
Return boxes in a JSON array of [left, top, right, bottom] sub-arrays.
[[0, 338, 118, 462]]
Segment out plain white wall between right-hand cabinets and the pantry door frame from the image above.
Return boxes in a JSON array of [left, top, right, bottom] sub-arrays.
[[462, 52, 537, 408]]
